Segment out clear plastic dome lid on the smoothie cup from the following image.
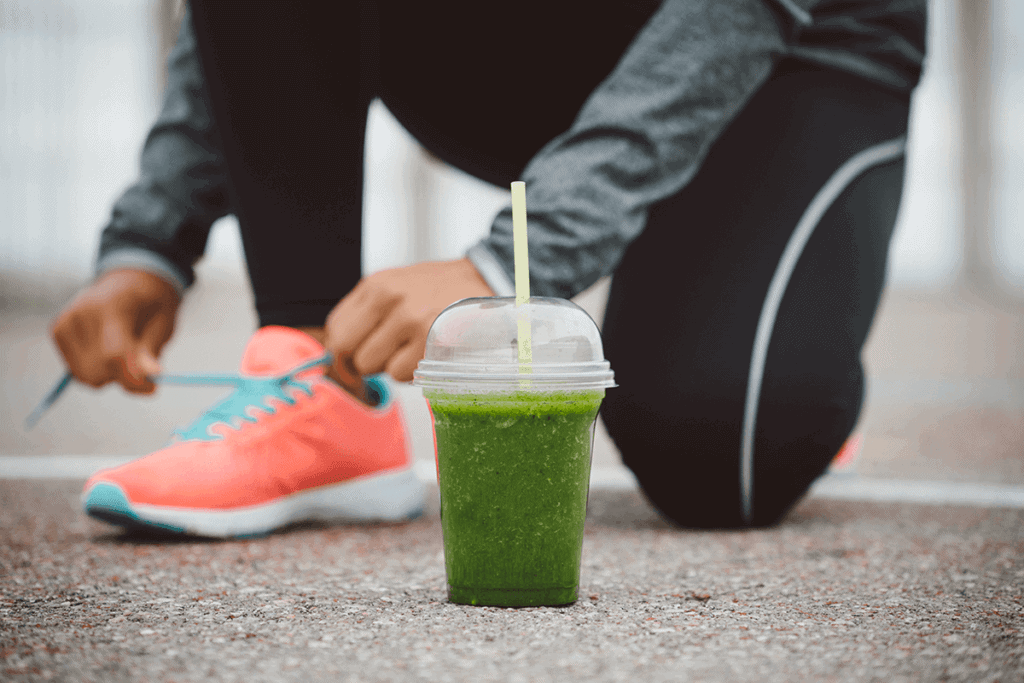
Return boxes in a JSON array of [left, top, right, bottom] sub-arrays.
[[413, 297, 615, 391]]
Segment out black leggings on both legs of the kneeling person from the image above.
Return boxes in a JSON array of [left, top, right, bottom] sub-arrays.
[[193, 2, 909, 526]]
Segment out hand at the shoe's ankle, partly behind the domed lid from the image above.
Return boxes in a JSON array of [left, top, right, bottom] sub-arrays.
[[325, 258, 495, 384]]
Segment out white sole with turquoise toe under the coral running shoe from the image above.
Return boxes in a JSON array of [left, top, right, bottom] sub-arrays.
[[82, 467, 424, 539]]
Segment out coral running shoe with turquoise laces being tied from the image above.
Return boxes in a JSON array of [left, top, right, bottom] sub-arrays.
[[82, 327, 424, 538]]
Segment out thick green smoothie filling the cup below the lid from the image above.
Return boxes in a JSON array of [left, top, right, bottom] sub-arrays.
[[424, 389, 604, 607]]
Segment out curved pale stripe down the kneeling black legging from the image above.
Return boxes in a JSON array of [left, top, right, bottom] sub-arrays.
[[739, 137, 906, 524]]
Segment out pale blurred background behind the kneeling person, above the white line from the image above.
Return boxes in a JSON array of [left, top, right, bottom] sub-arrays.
[[0, 0, 1024, 484]]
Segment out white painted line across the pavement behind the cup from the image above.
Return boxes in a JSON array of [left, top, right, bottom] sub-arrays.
[[0, 456, 1024, 510]]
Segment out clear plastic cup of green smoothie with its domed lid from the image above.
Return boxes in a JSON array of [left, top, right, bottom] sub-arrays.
[[414, 297, 615, 606]]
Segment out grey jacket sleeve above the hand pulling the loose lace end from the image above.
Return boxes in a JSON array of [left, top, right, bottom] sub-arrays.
[[96, 9, 230, 293]]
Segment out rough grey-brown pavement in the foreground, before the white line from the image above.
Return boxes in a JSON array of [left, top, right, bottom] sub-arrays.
[[0, 481, 1024, 683]]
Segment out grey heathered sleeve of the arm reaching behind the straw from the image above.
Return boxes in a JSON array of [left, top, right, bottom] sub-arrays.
[[468, 0, 786, 298]]
